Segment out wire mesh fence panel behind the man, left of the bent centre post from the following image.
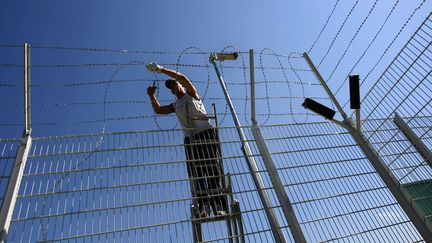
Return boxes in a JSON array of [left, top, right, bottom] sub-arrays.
[[8, 128, 289, 242]]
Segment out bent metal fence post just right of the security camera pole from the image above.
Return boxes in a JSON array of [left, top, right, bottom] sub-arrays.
[[249, 50, 306, 243]]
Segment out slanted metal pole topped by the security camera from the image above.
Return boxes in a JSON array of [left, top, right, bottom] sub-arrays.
[[211, 60, 286, 243]]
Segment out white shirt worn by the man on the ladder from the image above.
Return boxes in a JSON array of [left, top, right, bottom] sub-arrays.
[[172, 93, 212, 137]]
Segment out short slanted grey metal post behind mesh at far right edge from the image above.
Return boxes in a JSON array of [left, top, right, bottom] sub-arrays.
[[393, 113, 432, 168]]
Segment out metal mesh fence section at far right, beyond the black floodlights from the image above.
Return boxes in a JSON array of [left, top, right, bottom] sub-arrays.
[[362, 12, 432, 184]]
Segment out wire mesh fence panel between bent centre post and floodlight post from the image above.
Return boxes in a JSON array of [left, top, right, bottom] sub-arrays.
[[262, 123, 422, 242]]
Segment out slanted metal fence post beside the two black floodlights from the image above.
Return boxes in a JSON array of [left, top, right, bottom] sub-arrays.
[[303, 53, 432, 242]]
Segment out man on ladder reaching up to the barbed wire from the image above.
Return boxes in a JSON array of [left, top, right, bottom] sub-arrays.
[[147, 63, 227, 218]]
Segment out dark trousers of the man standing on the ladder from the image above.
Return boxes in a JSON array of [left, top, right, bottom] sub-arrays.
[[184, 129, 228, 214]]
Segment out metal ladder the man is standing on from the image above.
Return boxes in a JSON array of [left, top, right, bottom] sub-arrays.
[[188, 104, 245, 243]]
